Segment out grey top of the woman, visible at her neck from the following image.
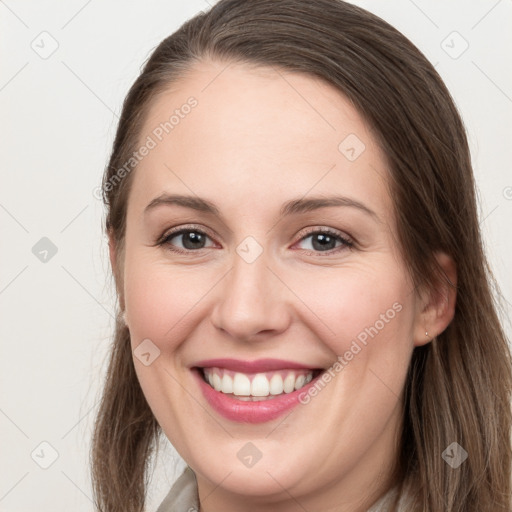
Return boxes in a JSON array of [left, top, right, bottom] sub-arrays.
[[156, 466, 408, 512]]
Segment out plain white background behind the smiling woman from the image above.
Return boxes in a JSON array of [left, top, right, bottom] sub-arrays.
[[0, 0, 512, 512]]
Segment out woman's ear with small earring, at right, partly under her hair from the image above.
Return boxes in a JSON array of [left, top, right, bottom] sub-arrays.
[[414, 253, 457, 346]]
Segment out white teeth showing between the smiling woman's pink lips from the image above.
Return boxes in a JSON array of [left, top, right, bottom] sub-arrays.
[[203, 368, 313, 401]]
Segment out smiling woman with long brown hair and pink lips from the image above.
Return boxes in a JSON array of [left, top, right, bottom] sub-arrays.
[[92, 0, 512, 512]]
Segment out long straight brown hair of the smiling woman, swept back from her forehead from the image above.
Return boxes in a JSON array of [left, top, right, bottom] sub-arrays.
[[91, 0, 512, 512]]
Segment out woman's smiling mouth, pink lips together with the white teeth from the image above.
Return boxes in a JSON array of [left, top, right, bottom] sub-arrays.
[[191, 359, 325, 423]]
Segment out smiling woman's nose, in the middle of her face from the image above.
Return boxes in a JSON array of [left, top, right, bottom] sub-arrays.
[[212, 247, 291, 341]]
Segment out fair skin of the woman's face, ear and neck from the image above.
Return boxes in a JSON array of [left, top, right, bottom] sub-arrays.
[[110, 61, 456, 512]]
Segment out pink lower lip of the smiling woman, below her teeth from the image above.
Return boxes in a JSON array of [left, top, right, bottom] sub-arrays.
[[193, 368, 318, 423]]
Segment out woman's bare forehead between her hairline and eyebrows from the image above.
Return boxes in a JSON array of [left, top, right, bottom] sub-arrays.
[[126, 61, 391, 220]]
